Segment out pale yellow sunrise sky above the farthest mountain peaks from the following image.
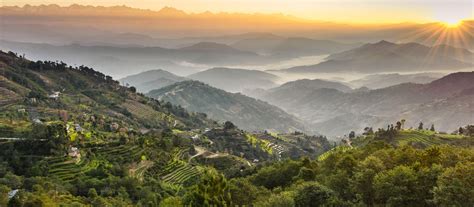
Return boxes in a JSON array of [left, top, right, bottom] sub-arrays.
[[0, 0, 474, 24]]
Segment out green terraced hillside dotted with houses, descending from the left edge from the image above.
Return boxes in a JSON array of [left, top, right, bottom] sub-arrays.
[[0, 52, 331, 206]]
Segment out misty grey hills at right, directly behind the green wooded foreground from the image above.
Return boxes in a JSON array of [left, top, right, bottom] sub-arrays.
[[254, 72, 474, 135]]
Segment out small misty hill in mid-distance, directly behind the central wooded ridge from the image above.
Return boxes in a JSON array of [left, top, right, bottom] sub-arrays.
[[187, 68, 279, 92]]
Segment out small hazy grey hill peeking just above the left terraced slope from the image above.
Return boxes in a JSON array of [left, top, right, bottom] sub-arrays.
[[119, 69, 186, 93]]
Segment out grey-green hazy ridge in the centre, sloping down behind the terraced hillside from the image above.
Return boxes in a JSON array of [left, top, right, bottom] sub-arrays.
[[147, 81, 305, 132]]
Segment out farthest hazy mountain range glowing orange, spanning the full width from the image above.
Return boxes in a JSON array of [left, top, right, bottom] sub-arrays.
[[0, 4, 474, 49]]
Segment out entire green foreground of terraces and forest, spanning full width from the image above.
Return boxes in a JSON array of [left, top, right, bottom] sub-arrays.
[[0, 52, 474, 207]]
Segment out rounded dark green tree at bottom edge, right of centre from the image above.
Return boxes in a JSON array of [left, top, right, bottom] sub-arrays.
[[294, 182, 337, 207]]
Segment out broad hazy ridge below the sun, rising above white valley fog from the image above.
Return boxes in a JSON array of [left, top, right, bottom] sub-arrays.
[[282, 41, 473, 73]]
